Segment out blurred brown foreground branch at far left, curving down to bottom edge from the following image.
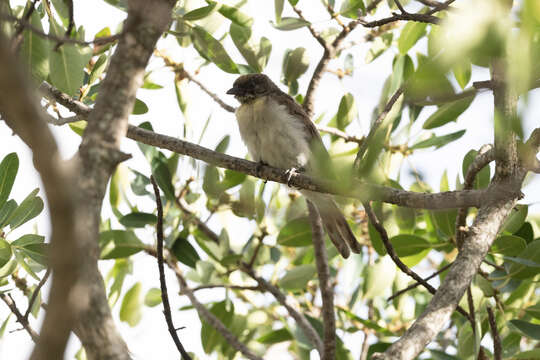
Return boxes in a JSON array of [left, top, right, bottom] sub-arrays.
[[0, 34, 81, 360]]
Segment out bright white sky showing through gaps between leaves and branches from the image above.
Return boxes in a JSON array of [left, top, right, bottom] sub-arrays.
[[0, 0, 540, 360]]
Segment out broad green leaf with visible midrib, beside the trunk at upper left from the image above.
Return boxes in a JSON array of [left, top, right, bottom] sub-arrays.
[[49, 17, 92, 96]]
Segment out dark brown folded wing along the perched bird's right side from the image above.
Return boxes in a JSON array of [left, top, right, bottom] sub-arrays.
[[275, 91, 334, 178]]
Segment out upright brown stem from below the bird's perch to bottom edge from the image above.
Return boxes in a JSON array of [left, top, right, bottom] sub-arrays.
[[307, 201, 336, 360]]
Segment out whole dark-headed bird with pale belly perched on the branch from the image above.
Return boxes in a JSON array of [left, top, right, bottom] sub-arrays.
[[227, 74, 361, 258]]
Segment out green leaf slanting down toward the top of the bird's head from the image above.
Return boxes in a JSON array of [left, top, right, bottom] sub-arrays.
[[191, 26, 239, 74]]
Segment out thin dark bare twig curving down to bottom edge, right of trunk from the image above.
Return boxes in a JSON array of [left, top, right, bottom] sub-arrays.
[[150, 175, 192, 360]]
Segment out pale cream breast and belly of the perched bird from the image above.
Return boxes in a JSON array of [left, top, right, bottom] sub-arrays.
[[236, 96, 311, 169]]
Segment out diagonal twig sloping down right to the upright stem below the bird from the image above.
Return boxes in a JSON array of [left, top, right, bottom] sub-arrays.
[[240, 264, 324, 354]]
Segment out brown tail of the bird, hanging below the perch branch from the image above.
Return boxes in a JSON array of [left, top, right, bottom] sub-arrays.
[[302, 190, 362, 258]]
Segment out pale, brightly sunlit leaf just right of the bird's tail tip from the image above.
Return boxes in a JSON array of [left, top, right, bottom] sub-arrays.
[[363, 255, 396, 300]]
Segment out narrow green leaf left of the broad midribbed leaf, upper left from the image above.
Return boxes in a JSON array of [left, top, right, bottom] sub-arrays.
[[21, 10, 49, 82]]
